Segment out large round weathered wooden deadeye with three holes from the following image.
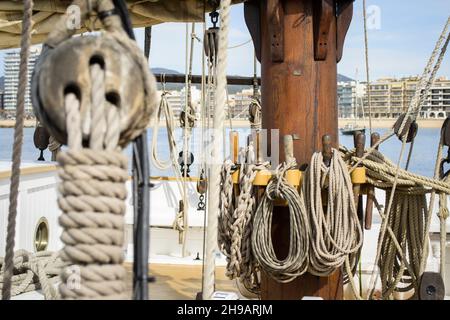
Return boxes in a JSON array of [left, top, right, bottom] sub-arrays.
[[32, 2, 158, 147]]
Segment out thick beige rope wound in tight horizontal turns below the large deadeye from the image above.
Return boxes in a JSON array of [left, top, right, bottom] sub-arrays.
[[58, 149, 128, 299]]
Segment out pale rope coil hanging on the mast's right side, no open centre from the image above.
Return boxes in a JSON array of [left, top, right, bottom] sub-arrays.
[[302, 149, 362, 276]]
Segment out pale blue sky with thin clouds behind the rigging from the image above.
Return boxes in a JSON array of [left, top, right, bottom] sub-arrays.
[[0, 0, 450, 80]]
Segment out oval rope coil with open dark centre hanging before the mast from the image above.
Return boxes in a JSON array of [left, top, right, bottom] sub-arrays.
[[252, 164, 310, 283]]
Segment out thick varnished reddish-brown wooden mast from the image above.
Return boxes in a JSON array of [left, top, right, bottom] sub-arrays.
[[245, 0, 353, 299]]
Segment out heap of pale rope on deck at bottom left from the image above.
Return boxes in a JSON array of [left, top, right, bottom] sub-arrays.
[[0, 250, 64, 300]]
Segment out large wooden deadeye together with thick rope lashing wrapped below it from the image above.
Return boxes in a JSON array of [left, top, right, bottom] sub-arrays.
[[31, 0, 158, 299]]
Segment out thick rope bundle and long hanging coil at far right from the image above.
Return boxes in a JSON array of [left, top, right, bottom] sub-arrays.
[[341, 141, 450, 299]]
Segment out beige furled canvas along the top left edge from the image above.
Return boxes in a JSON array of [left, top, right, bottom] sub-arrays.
[[0, 0, 242, 49]]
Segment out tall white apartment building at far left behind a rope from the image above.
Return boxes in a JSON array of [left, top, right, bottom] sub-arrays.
[[4, 47, 40, 111]]
